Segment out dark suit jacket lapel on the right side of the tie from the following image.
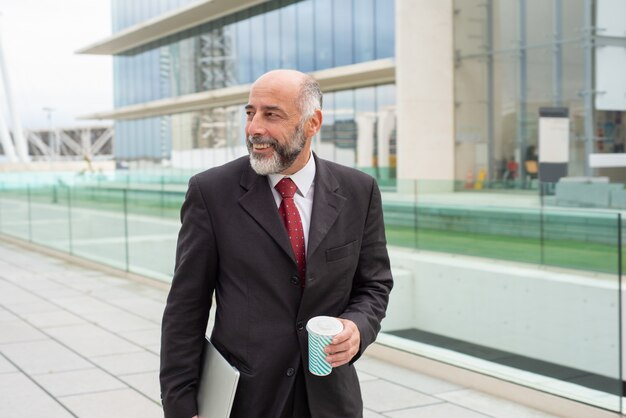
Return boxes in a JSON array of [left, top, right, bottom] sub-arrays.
[[307, 154, 346, 258]]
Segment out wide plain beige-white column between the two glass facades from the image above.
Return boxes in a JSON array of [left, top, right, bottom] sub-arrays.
[[396, 0, 454, 184]]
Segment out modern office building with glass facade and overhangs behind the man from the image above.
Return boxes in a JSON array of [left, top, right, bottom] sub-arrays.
[[82, 0, 626, 185]]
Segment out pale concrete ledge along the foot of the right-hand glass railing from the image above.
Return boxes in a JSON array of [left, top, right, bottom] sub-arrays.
[[366, 343, 622, 418]]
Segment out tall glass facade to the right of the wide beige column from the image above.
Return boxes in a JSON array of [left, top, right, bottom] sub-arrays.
[[454, 0, 626, 181]]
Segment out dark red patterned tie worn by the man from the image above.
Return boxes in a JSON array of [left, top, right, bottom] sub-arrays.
[[274, 177, 306, 287]]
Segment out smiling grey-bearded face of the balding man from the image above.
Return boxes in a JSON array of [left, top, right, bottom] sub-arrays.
[[246, 70, 322, 175]]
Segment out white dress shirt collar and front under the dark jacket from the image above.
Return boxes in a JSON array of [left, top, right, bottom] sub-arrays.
[[267, 153, 315, 254]]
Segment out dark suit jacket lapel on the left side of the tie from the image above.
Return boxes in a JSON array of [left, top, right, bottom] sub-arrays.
[[239, 165, 296, 263]]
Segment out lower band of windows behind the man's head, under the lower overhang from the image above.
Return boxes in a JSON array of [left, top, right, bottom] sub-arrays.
[[117, 84, 396, 178]]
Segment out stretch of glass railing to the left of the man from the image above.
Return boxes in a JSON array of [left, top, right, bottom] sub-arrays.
[[0, 182, 184, 281]]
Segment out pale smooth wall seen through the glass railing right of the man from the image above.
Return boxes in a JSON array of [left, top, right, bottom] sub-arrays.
[[383, 249, 619, 378]]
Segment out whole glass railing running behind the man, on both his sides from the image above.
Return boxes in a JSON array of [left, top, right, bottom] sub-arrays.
[[0, 172, 626, 411]]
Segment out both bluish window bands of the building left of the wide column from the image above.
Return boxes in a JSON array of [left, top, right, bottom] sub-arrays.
[[114, 0, 395, 181]]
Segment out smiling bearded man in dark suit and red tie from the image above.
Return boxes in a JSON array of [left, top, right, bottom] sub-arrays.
[[161, 70, 392, 418]]
